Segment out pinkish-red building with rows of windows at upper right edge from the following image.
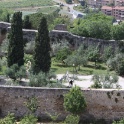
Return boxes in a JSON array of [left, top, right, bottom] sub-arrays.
[[101, 6, 124, 20]]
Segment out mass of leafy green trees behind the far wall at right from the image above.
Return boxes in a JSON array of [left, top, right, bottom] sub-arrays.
[[71, 13, 124, 40]]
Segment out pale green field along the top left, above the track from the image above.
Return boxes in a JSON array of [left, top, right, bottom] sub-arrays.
[[0, 0, 54, 9]]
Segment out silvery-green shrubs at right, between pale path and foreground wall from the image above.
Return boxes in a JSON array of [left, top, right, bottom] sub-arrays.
[[91, 72, 118, 89]]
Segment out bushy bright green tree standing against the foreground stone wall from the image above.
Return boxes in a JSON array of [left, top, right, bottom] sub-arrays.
[[64, 86, 87, 114]]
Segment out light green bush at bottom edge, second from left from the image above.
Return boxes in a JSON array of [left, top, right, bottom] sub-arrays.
[[19, 114, 38, 124]]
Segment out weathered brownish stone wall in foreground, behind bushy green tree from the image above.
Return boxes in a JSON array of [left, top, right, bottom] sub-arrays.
[[0, 86, 124, 122]]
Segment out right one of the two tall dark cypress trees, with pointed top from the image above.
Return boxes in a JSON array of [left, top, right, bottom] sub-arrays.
[[33, 17, 51, 73]]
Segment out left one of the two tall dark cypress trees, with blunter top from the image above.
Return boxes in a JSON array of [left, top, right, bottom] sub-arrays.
[[7, 12, 24, 67]]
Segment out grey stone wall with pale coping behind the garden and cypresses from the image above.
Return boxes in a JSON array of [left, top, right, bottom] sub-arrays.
[[0, 22, 117, 51]]
